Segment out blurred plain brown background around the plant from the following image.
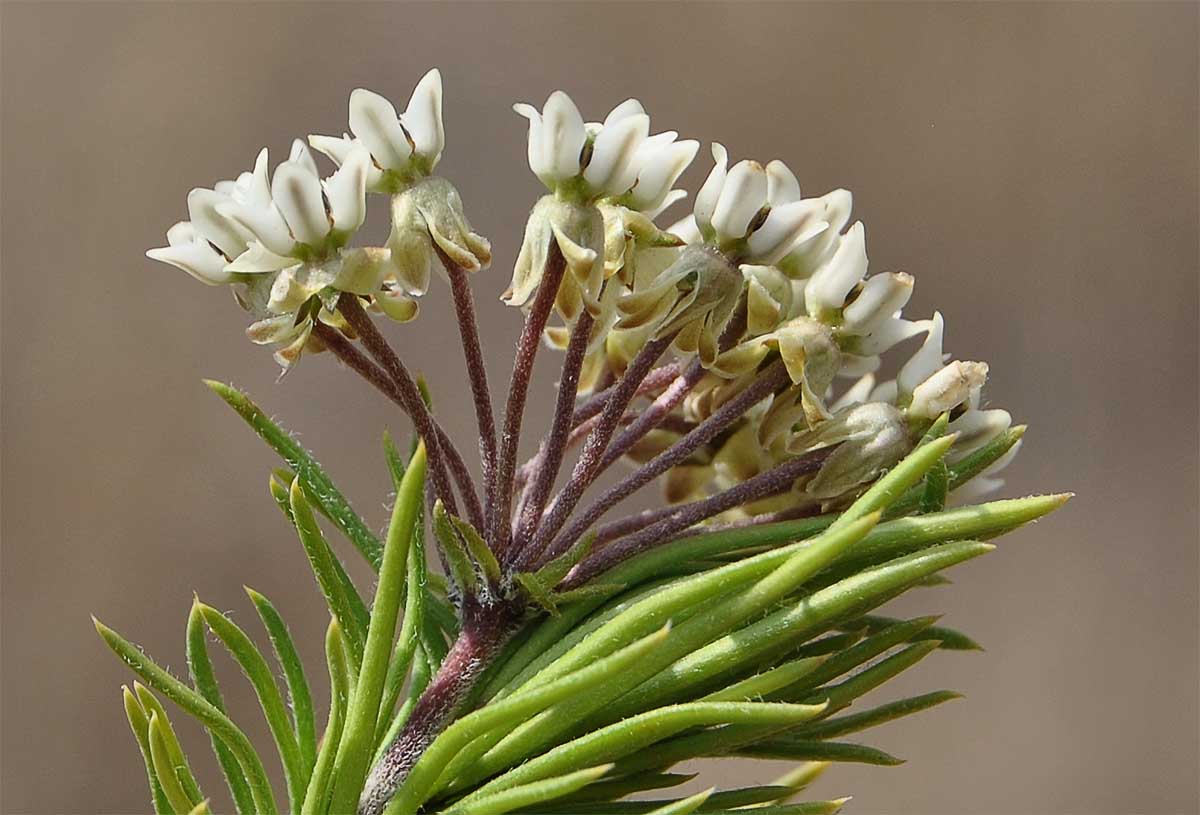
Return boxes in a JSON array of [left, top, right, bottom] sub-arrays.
[[0, 2, 1198, 814]]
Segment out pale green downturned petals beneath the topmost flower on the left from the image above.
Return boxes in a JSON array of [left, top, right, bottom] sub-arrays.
[[388, 175, 492, 295]]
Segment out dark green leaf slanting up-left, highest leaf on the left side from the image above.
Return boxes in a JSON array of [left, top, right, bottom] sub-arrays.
[[204, 379, 383, 566]]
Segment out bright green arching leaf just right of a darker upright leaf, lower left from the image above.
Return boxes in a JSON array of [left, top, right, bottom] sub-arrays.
[[196, 600, 308, 811]]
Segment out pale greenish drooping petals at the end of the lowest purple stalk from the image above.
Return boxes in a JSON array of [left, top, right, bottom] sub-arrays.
[[787, 402, 912, 501]]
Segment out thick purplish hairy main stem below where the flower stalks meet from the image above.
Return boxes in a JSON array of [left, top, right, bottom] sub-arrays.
[[359, 600, 523, 815]]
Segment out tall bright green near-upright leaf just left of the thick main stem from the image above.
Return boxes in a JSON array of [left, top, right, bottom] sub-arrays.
[[330, 445, 425, 813]]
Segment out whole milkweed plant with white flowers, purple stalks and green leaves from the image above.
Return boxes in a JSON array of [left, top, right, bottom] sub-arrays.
[[96, 70, 1068, 815]]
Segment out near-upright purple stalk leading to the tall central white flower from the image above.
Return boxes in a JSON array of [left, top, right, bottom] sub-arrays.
[[487, 241, 566, 557]]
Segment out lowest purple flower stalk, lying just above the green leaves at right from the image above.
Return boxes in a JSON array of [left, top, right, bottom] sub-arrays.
[[563, 445, 836, 591]]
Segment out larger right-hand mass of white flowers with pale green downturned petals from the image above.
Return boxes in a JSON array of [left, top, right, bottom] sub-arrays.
[[508, 91, 1012, 509]]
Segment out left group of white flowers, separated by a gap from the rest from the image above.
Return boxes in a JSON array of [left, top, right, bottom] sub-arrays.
[[146, 70, 491, 370]]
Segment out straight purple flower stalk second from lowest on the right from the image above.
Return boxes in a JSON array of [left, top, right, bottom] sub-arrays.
[[541, 360, 788, 571]]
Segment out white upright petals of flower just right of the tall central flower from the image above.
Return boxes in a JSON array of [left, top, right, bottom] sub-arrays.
[[685, 143, 828, 265]]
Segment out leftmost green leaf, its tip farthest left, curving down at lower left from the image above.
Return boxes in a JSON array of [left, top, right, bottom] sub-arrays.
[[92, 617, 278, 815]]
